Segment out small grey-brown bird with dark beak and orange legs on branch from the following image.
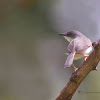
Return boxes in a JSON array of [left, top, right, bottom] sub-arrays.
[[59, 30, 93, 71]]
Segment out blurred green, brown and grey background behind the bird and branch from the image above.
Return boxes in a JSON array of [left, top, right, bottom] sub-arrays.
[[0, 0, 100, 100]]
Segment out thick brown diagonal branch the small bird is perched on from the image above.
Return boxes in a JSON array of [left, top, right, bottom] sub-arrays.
[[56, 40, 100, 100]]
